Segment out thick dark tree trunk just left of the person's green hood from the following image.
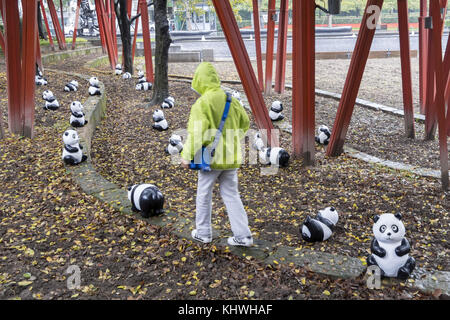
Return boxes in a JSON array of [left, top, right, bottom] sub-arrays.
[[150, 0, 172, 105]]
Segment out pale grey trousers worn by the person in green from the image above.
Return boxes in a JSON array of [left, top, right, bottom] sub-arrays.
[[195, 169, 251, 238]]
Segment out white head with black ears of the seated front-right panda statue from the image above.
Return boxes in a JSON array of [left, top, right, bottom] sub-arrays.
[[373, 213, 405, 242]]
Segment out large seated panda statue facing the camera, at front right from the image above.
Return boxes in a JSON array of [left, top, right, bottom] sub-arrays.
[[367, 213, 416, 280]]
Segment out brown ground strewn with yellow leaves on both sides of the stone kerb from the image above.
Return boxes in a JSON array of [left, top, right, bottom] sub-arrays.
[[0, 53, 449, 299]]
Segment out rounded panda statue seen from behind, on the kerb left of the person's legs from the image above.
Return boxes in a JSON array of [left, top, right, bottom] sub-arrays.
[[128, 184, 164, 218]]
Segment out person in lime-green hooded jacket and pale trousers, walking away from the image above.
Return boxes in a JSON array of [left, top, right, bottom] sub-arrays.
[[181, 62, 253, 246]]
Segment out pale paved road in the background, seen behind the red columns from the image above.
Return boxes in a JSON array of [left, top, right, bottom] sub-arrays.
[[175, 34, 448, 59]]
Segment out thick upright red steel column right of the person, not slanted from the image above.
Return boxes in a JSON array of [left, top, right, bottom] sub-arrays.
[[292, 0, 316, 165]]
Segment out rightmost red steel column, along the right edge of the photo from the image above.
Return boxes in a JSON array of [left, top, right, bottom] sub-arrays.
[[430, 1, 449, 190]]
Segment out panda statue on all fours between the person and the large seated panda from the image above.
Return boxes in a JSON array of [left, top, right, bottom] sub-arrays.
[[300, 207, 339, 242]]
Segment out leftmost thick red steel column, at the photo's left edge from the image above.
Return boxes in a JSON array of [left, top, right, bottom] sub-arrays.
[[2, 0, 23, 134]]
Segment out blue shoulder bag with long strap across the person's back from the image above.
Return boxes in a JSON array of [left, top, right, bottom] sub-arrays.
[[189, 92, 231, 172]]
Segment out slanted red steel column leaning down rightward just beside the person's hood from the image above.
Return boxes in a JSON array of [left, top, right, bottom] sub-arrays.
[[213, 0, 279, 147]]
